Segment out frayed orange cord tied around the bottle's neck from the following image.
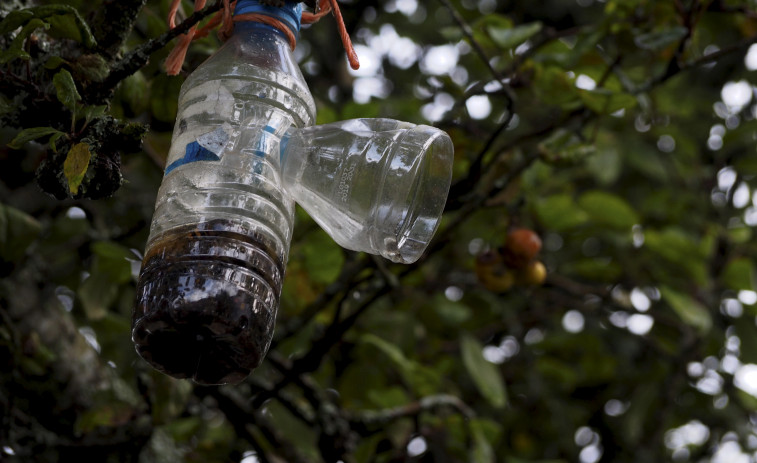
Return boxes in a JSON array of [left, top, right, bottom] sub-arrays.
[[166, 0, 360, 76]]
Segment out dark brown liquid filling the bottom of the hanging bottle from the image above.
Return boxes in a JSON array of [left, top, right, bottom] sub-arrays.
[[132, 219, 284, 384]]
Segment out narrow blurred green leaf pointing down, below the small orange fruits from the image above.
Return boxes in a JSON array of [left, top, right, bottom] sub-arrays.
[[460, 333, 507, 408]]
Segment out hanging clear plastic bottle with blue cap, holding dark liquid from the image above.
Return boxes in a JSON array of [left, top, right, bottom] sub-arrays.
[[132, 0, 315, 384]]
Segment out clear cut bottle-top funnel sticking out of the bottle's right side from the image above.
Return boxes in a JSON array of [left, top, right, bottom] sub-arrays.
[[281, 119, 454, 264]]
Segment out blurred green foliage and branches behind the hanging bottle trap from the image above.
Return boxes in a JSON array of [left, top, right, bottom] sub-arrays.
[[0, 0, 757, 463]]
